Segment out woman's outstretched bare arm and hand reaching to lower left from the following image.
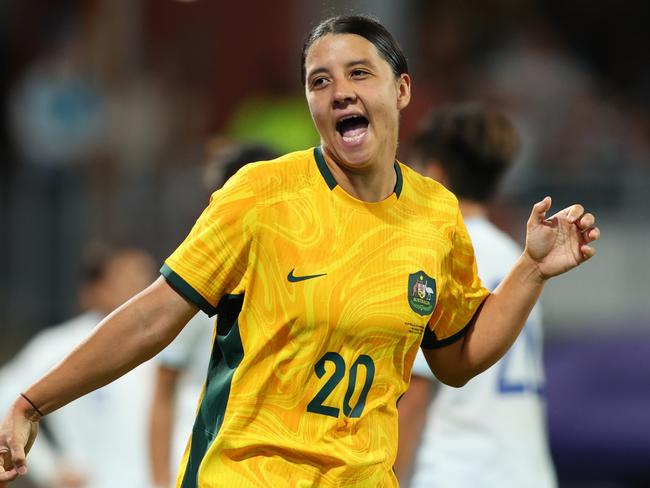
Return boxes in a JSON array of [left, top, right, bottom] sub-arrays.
[[0, 277, 197, 482]]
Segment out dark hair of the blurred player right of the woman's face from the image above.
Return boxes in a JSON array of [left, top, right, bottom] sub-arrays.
[[413, 104, 519, 203]]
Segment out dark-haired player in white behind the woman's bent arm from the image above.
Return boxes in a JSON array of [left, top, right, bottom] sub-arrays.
[[396, 104, 557, 488]]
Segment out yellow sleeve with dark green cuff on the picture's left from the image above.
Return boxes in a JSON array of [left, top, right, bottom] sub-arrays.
[[160, 169, 256, 316]]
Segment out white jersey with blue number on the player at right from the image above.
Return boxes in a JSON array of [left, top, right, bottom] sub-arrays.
[[411, 218, 557, 488]]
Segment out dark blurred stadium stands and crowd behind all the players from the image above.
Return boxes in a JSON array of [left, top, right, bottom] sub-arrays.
[[0, 0, 650, 487]]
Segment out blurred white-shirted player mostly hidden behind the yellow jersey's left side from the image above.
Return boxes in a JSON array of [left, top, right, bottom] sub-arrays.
[[149, 137, 278, 488]]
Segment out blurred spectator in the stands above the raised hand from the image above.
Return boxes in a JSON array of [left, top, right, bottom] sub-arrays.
[[474, 18, 647, 205]]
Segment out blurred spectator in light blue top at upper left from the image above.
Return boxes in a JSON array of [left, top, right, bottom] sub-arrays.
[[0, 21, 106, 330]]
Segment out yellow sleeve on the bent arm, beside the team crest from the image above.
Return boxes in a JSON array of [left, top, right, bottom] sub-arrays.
[[422, 210, 490, 349]]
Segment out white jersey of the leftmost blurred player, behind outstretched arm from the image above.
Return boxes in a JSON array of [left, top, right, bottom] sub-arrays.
[[0, 313, 154, 488]]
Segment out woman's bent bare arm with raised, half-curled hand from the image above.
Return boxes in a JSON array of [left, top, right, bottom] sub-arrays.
[[424, 197, 600, 386]]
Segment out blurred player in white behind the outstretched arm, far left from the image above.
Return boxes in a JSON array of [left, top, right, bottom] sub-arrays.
[[0, 244, 155, 488]]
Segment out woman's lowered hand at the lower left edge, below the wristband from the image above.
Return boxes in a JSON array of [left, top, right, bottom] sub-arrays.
[[0, 397, 41, 488]]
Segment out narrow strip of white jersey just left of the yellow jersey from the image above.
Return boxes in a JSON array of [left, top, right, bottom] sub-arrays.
[[155, 312, 215, 469]]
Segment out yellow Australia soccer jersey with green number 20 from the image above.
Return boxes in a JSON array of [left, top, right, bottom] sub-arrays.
[[161, 148, 488, 488]]
